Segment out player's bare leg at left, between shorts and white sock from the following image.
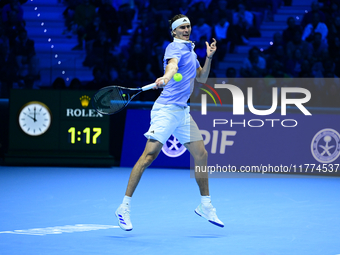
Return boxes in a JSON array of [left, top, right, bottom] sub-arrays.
[[125, 139, 163, 197]]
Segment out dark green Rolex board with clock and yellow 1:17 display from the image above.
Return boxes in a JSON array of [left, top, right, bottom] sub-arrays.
[[5, 90, 114, 165]]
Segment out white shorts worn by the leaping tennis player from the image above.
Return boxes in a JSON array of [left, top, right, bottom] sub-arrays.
[[144, 103, 203, 144]]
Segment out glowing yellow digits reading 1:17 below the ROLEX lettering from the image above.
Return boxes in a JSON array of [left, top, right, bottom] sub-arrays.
[[68, 127, 102, 144]]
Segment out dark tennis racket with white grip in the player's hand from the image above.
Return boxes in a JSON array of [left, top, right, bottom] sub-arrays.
[[92, 83, 156, 115]]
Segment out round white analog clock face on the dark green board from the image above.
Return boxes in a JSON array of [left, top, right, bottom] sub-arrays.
[[19, 101, 52, 136]]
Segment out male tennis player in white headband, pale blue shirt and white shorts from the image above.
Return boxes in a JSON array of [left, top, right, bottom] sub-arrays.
[[115, 14, 224, 231]]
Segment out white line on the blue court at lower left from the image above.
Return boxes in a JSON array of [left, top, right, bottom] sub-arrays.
[[0, 224, 119, 236]]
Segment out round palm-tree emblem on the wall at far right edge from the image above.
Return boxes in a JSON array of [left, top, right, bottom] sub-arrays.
[[311, 128, 340, 163]]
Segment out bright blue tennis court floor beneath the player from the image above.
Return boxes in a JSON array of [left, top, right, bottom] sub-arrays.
[[0, 167, 340, 255]]
